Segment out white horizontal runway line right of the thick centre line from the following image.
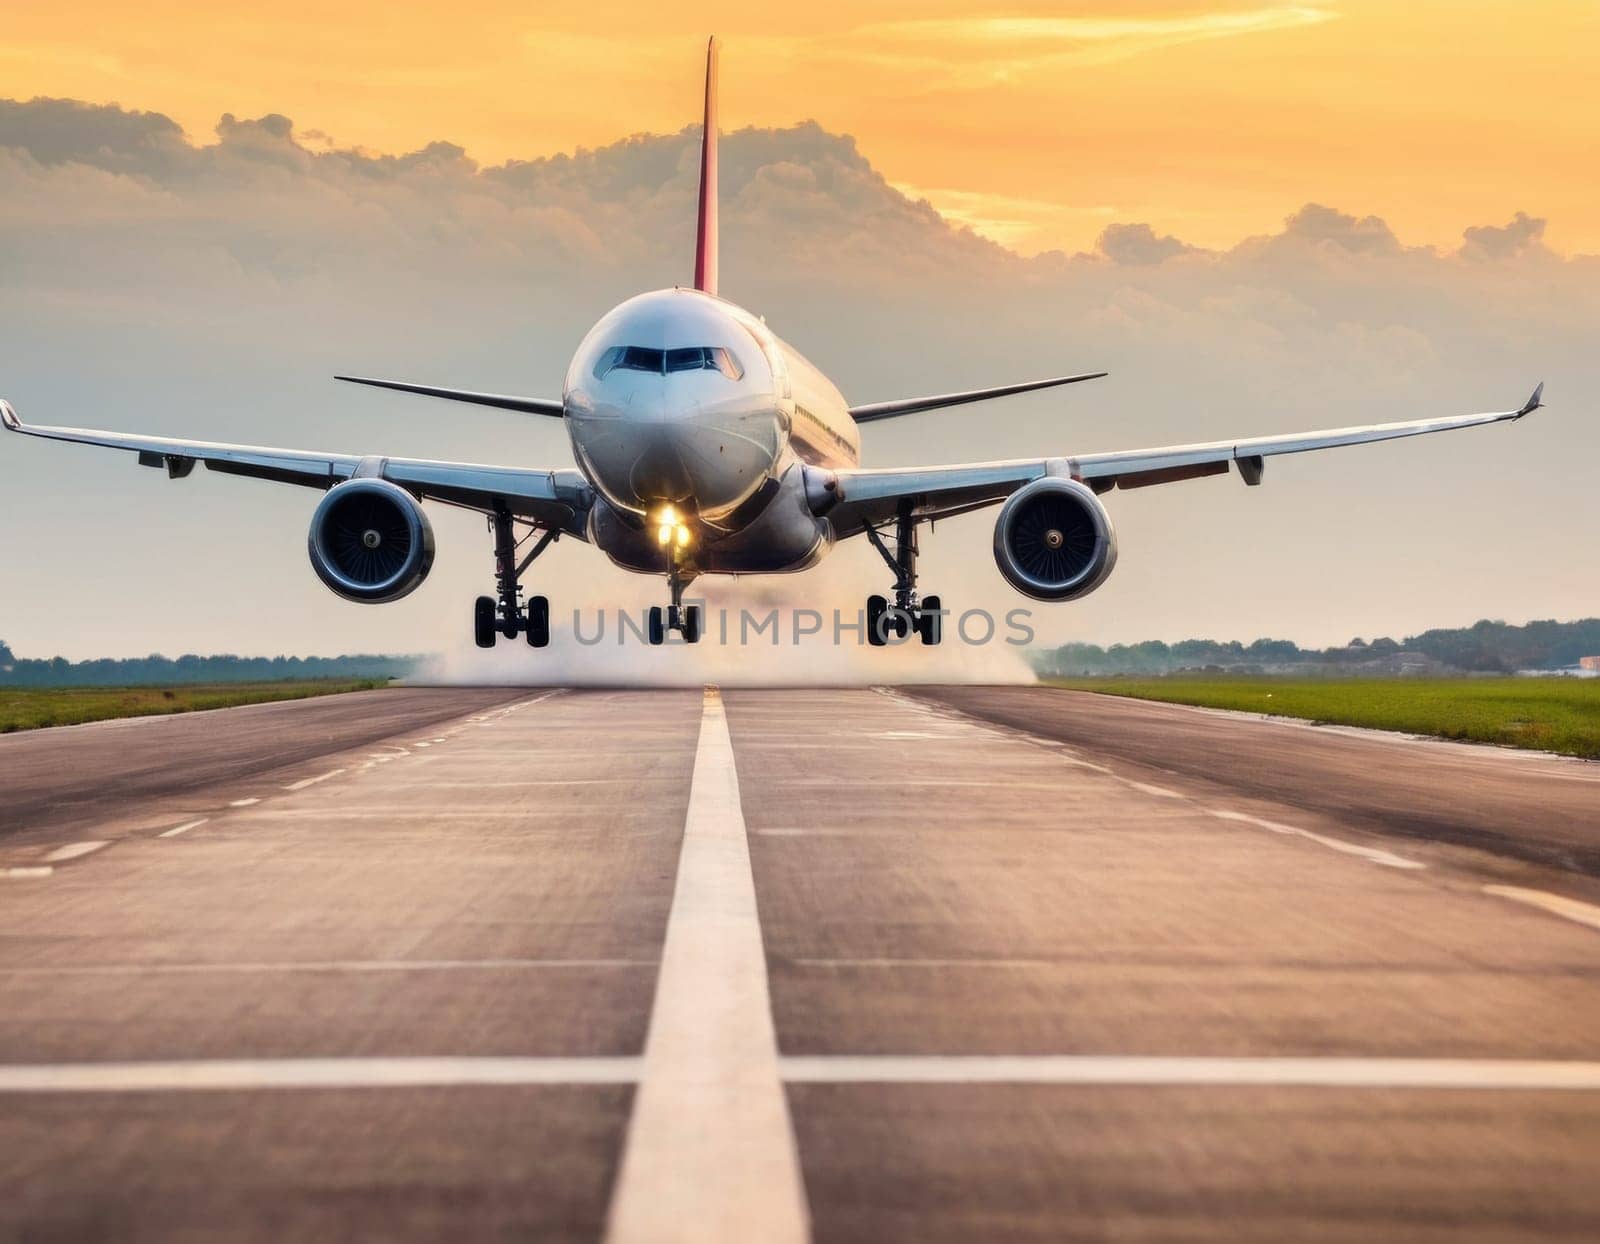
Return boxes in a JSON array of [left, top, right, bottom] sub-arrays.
[[782, 1054, 1600, 1090]]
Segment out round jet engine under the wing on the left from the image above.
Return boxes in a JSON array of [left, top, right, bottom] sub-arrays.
[[306, 480, 434, 604]]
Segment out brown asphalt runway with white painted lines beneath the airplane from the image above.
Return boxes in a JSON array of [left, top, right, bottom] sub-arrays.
[[0, 688, 1600, 1241]]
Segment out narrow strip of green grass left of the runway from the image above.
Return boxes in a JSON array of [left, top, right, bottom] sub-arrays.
[[0, 678, 386, 734]]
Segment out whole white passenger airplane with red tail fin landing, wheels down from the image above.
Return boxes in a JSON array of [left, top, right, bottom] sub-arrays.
[[0, 38, 1544, 648]]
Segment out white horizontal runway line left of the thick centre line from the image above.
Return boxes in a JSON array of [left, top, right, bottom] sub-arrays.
[[0, 1059, 640, 1092]]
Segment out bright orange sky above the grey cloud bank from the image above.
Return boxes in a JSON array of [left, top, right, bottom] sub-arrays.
[[0, 0, 1600, 253]]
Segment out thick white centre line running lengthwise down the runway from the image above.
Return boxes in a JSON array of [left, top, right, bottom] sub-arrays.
[[606, 688, 810, 1244]]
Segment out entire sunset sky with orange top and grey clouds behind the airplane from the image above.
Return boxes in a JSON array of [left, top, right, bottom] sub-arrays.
[[0, 3, 1600, 657]]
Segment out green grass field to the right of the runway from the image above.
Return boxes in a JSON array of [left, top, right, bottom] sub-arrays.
[[1048, 675, 1600, 760]]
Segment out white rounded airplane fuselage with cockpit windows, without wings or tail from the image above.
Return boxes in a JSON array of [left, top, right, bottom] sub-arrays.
[[562, 288, 861, 572]]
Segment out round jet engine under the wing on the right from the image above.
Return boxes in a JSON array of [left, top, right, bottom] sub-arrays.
[[995, 475, 1117, 601]]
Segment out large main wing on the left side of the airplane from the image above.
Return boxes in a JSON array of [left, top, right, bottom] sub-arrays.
[[0, 400, 594, 539]]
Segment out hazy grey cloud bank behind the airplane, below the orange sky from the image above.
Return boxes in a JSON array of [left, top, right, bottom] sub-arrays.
[[0, 101, 1600, 656]]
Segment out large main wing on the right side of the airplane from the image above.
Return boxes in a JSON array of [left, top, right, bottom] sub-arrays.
[[827, 384, 1544, 539]]
